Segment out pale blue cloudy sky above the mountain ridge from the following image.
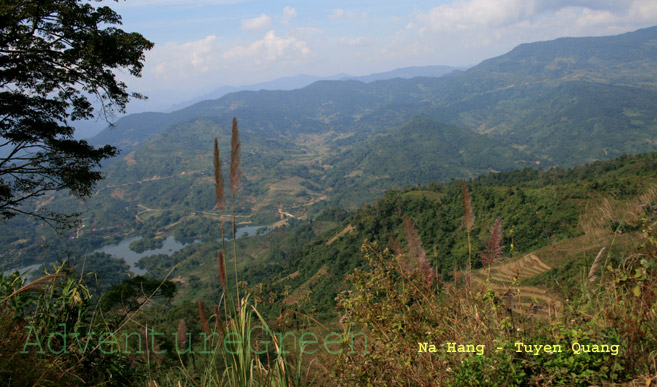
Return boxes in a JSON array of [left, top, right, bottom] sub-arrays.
[[101, 0, 657, 110]]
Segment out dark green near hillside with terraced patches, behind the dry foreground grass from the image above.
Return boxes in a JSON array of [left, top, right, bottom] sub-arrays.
[[165, 153, 657, 319]]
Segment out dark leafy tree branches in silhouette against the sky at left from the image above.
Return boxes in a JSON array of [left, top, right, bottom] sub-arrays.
[[0, 0, 153, 223]]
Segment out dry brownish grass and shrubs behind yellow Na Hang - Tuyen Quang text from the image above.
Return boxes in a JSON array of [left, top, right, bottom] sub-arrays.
[[326, 195, 657, 386]]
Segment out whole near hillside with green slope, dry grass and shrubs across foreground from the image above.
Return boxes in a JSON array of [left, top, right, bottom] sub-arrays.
[[0, 153, 657, 386]]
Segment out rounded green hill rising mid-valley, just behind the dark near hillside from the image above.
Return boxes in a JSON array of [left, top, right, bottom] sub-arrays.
[[317, 116, 534, 207]]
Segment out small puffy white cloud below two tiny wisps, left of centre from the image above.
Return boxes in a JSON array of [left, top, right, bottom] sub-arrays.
[[223, 31, 310, 65]]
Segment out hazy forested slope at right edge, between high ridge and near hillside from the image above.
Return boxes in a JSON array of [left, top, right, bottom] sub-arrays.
[[432, 81, 657, 166]]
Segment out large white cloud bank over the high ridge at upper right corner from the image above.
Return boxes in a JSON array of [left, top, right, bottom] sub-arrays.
[[380, 0, 657, 71]]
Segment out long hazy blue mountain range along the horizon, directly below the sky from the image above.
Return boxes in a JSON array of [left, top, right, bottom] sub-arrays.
[[93, 27, 657, 165]]
